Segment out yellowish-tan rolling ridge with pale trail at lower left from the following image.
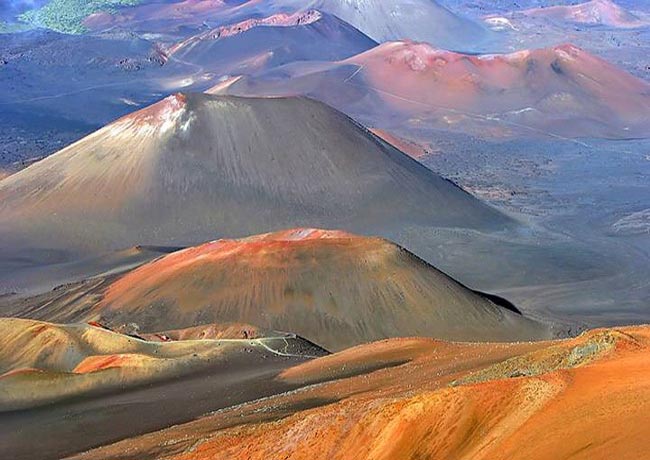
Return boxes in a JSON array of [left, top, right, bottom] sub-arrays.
[[0, 318, 326, 412]]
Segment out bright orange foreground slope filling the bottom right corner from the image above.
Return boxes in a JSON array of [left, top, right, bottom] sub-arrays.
[[76, 326, 650, 460]]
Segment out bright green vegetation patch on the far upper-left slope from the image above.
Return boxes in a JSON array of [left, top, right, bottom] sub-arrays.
[[19, 0, 140, 34]]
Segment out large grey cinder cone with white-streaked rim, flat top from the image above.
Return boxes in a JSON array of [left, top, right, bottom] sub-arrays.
[[0, 94, 511, 251]]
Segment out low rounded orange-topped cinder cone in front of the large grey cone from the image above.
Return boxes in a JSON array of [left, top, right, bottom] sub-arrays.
[[77, 229, 550, 350]]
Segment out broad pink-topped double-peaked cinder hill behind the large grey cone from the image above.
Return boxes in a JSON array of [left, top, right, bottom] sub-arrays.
[[219, 42, 650, 138]]
